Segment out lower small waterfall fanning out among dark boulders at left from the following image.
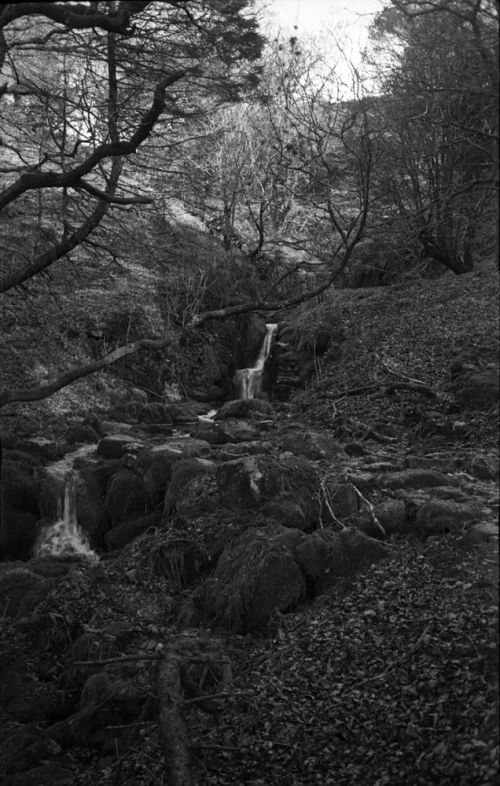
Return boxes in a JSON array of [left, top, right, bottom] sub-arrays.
[[33, 446, 99, 562]]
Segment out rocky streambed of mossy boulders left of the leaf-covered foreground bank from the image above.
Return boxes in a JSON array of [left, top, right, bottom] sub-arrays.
[[0, 400, 498, 785]]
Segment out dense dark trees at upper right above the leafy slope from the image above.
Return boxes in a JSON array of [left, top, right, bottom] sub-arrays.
[[366, 0, 498, 273]]
